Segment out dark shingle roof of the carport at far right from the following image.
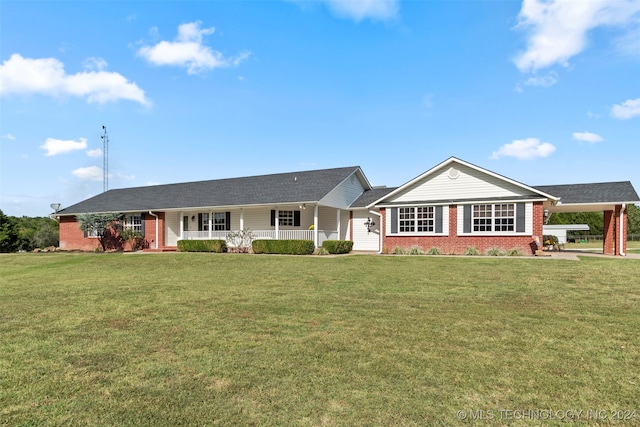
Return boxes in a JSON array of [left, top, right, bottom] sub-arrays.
[[534, 181, 640, 204]]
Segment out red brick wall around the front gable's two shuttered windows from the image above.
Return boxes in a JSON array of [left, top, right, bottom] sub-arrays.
[[380, 202, 544, 255]]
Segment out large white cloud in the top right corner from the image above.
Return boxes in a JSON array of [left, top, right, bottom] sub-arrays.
[[514, 0, 640, 72]]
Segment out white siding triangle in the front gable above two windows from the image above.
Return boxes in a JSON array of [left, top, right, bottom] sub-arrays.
[[392, 163, 534, 203]]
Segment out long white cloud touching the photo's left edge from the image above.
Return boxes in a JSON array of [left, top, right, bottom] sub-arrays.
[[0, 53, 149, 105]]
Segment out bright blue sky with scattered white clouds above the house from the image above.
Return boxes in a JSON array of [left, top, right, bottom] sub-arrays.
[[0, 0, 640, 216]]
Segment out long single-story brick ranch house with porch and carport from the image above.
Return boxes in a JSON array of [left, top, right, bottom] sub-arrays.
[[55, 157, 640, 255]]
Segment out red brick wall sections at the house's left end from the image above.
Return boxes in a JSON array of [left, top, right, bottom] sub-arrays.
[[59, 212, 165, 251]]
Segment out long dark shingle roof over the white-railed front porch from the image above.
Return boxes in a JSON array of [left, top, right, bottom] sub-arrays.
[[57, 166, 370, 215]]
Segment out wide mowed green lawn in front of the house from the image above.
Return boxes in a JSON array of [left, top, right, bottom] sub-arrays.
[[0, 253, 640, 426]]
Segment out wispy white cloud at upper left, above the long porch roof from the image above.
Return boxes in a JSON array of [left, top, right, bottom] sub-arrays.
[[138, 21, 251, 74]]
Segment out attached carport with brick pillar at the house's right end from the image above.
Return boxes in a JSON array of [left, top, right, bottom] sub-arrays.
[[535, 181, 640, 256]]
